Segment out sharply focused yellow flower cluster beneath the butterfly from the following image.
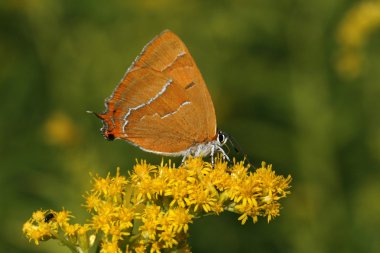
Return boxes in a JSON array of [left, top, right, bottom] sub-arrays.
[[23, 158, 291, 253]]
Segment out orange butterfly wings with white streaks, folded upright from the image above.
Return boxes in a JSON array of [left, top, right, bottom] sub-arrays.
[[98, 31, 216, 154]]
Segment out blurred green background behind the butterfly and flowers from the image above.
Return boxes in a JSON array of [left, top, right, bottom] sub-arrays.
[[0, 0, 380, 252]]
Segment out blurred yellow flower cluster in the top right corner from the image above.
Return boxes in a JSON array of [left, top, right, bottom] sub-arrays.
[[336, 0, 380, 79]]
